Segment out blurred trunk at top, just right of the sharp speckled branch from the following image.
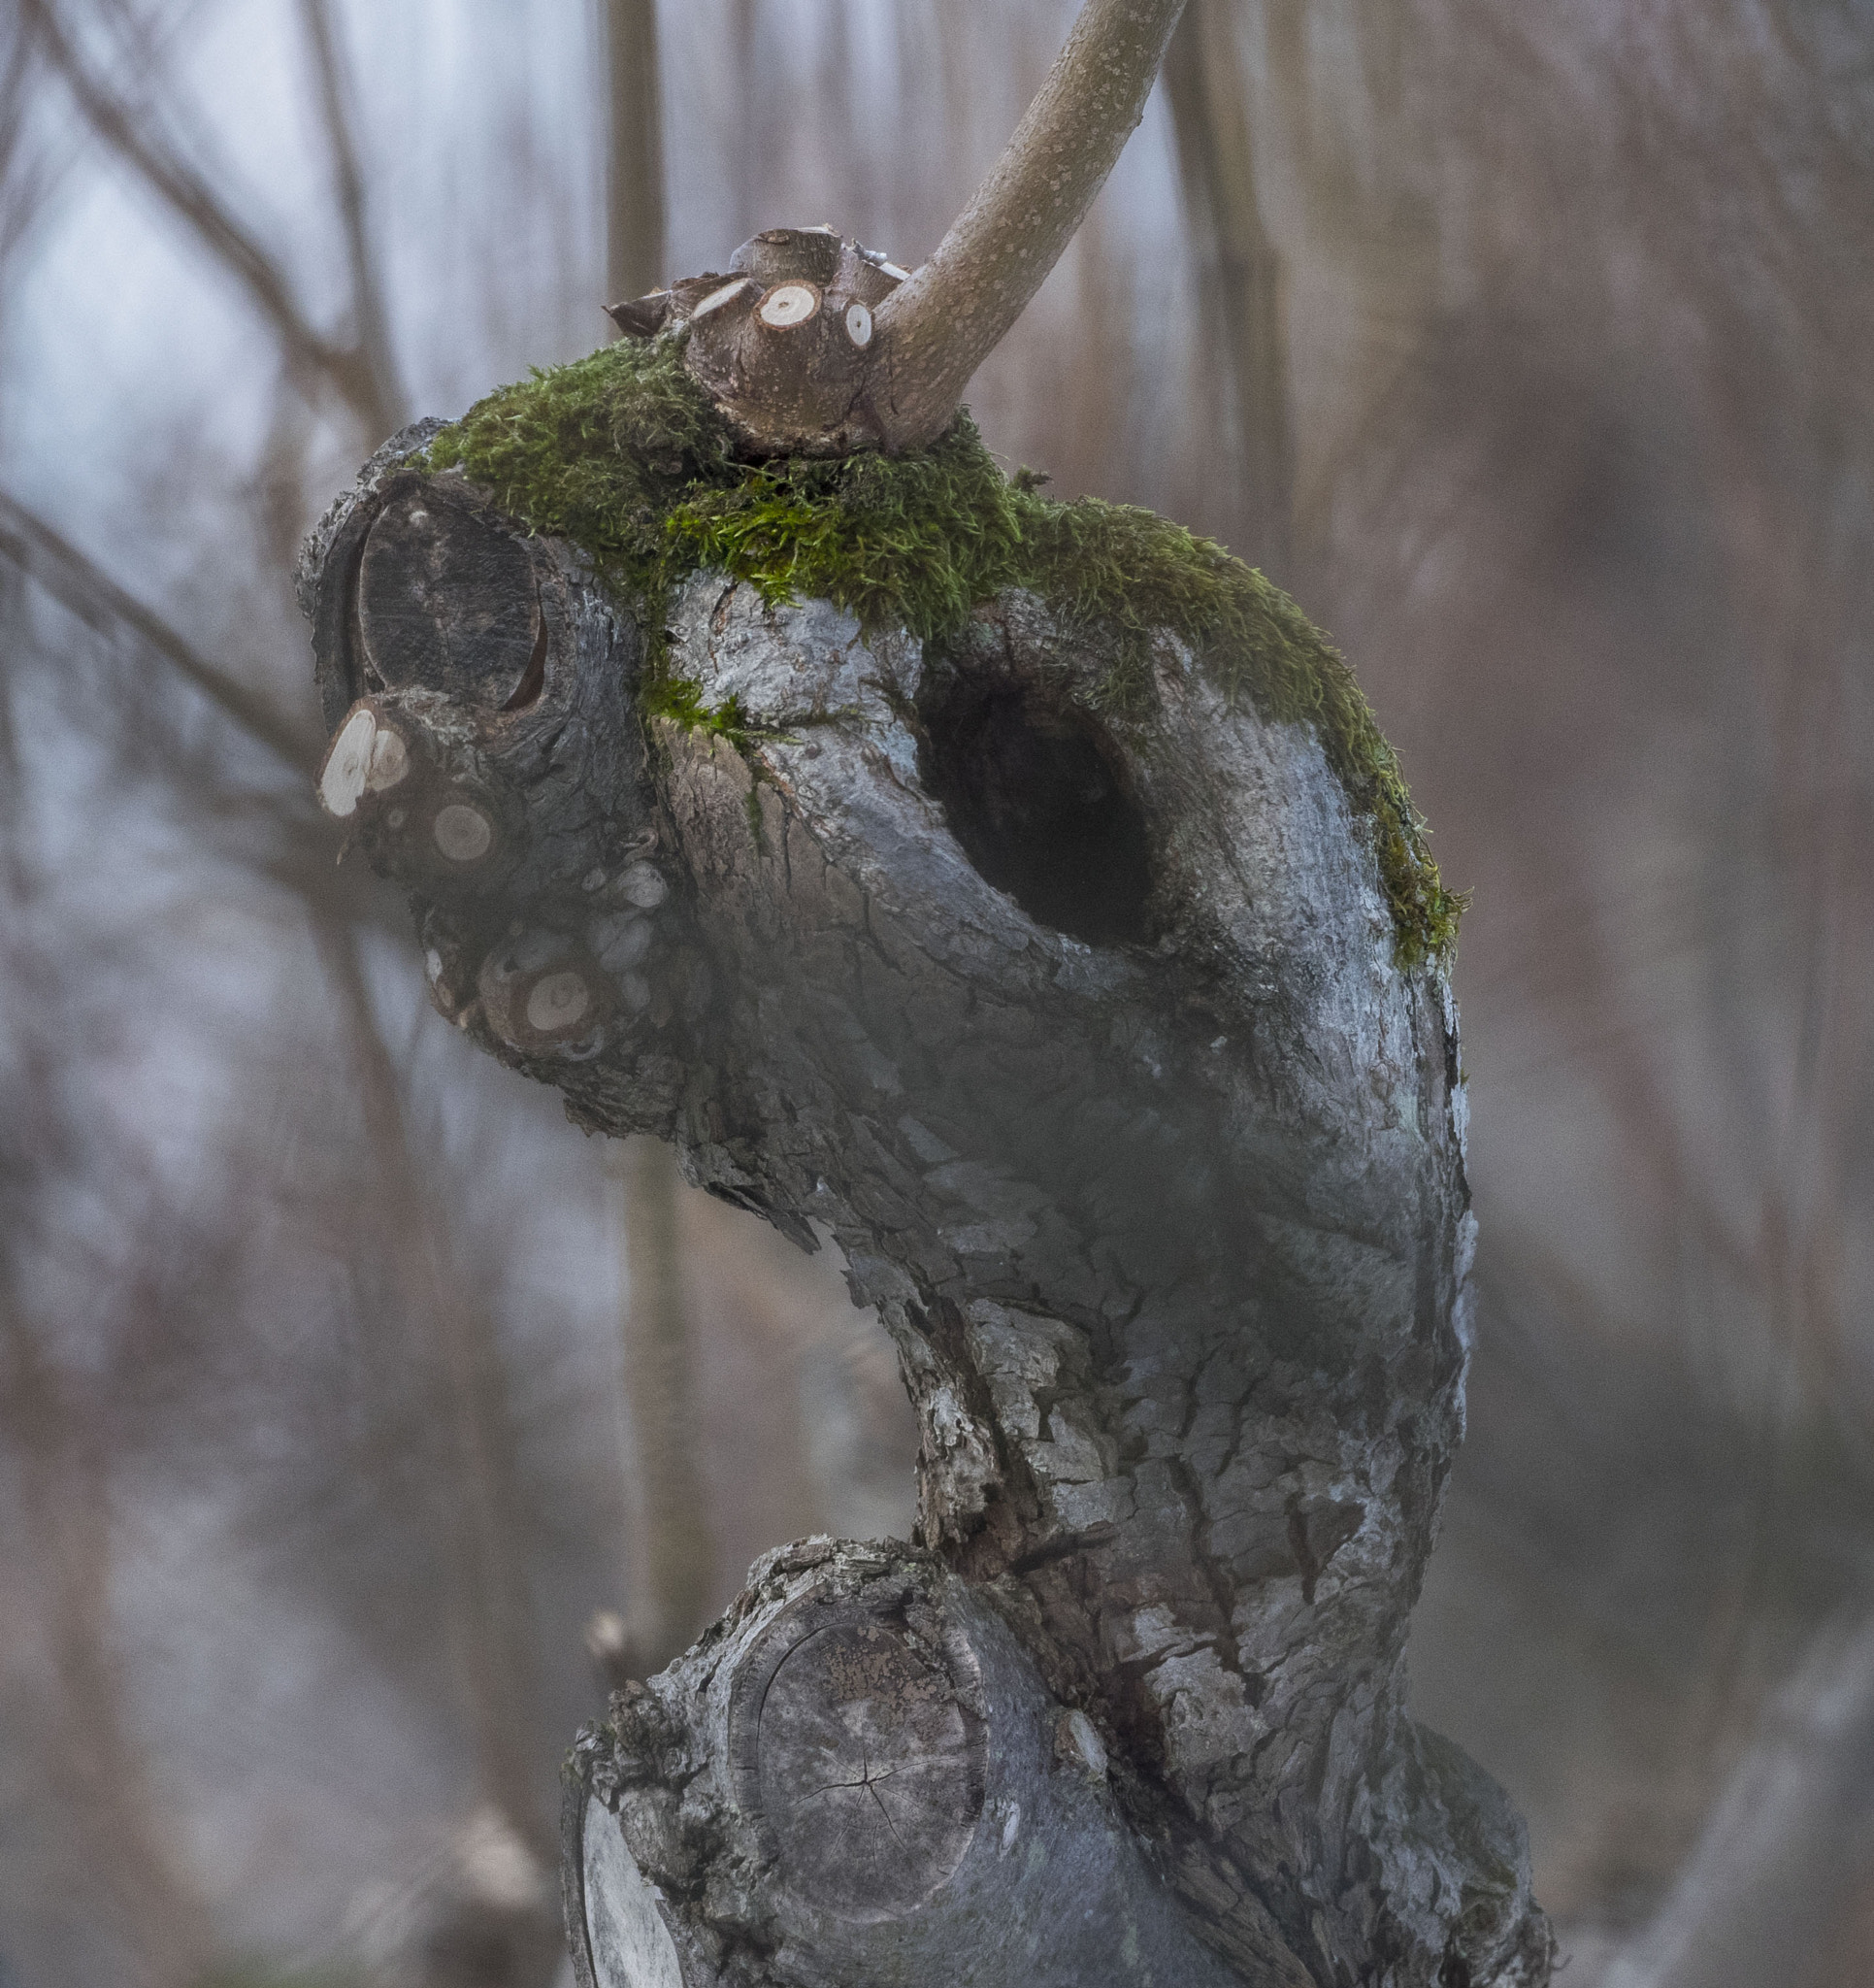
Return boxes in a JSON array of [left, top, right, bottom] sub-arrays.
[[1165, 0, 1294, 586]]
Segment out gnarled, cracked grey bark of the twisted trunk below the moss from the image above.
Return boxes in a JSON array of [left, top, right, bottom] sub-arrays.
[[302, 439, 1552, 1988]]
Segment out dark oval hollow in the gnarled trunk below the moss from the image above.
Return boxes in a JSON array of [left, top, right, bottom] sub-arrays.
[[924, 684, 1153, 946]]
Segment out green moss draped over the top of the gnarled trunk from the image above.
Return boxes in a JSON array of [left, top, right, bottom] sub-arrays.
[[415, 340, 1464, 964]]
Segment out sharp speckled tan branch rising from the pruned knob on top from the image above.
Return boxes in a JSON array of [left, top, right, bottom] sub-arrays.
[[876, 0, 1184, 449]]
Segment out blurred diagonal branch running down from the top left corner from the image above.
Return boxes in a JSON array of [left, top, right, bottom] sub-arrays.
[[22, 0, 387, 433]]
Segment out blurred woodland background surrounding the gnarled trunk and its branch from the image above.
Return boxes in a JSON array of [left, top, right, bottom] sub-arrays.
[[0, 0, 1874, 1988]]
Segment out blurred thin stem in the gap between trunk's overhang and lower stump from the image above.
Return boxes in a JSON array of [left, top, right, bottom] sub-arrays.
[[620, 1140, 715, 1670]]
